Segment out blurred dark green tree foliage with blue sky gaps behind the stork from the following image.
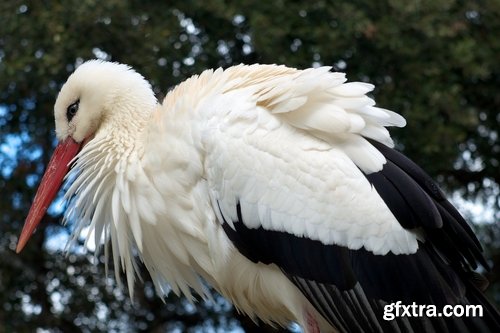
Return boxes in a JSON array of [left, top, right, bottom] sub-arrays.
[[0, 0, 500, 332]]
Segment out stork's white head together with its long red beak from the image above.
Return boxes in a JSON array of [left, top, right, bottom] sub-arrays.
[[16, 60, 156, 252]]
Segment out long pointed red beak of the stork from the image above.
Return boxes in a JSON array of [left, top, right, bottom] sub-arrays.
[[16, 137, 82, 253]]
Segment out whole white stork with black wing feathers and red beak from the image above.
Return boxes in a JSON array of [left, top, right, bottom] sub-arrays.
[[16, 59, 500, 333]]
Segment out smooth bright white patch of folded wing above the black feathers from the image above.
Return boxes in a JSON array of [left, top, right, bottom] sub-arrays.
[[204, 87, 418, 254]]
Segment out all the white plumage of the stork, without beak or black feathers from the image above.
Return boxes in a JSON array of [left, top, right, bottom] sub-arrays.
[[18, 61, 498, 332]]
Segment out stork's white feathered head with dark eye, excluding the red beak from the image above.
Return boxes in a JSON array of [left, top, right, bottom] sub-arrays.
[[54, 60, 156, 143]]
